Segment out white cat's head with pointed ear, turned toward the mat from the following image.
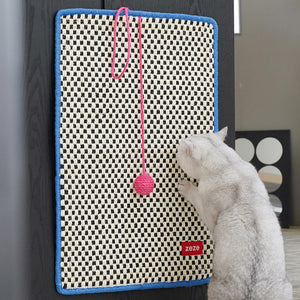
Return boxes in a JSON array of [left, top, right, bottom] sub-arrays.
[[176, 127, 227, 179]]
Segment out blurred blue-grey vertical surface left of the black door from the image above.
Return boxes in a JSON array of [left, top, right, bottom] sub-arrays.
[[0, 0, 29, 300]]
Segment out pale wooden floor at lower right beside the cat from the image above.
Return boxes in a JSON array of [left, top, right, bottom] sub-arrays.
[[282, 227, 300, 300]]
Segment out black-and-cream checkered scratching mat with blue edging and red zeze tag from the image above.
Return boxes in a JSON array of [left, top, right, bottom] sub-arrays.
[[55, 9, 218, 294]]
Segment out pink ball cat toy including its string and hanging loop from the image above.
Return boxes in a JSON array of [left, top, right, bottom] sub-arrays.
[[111, 7, 155, 196]]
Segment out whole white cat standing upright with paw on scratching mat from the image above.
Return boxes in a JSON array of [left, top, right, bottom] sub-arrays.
[[177, 128, 292, 300]]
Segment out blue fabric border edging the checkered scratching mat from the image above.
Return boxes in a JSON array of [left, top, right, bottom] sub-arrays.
[[55, 8, 219, 295]]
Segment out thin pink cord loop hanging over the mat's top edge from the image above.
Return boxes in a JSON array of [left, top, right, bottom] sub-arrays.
[[111, 7, 131, 79]]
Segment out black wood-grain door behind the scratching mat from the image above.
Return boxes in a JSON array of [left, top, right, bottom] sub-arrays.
[[23, 0, 234, 300]]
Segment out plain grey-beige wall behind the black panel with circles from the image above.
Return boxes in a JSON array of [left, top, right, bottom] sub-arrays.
[[235, 0, 300, 225]]
